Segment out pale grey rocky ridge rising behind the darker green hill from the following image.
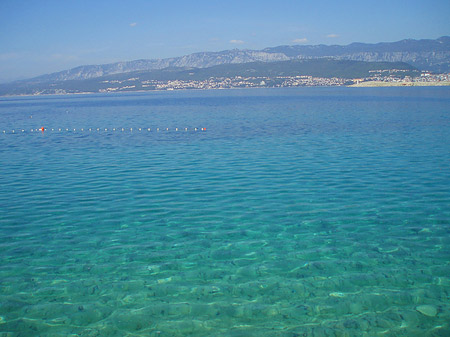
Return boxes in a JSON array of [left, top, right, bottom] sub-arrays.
[[28, 36, 450, 82]]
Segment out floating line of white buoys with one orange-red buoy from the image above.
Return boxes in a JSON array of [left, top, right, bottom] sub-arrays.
[[2, 127, 206, 134]]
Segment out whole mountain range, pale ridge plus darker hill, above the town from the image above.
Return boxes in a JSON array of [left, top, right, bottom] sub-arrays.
[[0, 36, 450, 95]]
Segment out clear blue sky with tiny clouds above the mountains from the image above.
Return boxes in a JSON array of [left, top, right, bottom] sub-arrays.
[[0, 0, 450, 82]]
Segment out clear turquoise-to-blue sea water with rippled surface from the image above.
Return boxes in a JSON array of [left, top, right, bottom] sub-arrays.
[[0, 88, 450, 336]]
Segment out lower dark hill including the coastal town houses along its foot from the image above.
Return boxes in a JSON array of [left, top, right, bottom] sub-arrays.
[[0, 58, 420, 95]]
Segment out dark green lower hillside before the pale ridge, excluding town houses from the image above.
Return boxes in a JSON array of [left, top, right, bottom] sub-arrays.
[[0, 58, 419, 95]]
